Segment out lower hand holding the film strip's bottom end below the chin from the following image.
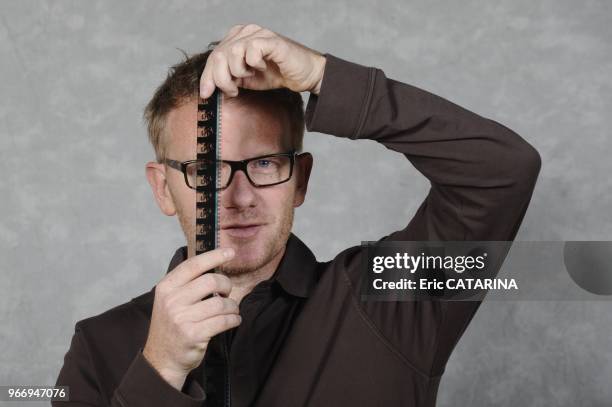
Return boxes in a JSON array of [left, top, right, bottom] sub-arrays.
[[143, 249, 241, 391]]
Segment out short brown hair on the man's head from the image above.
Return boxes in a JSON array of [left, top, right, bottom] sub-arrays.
[[143, 42, 304, 162]]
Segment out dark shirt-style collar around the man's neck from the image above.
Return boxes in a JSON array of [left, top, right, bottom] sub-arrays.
[[166, 233, 319, 298]]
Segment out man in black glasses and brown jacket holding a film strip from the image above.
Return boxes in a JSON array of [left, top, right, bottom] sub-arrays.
[[52, 25, 540, 407]]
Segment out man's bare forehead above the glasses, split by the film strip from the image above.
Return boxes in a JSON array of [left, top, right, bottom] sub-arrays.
[[166, 99, 290, 161]]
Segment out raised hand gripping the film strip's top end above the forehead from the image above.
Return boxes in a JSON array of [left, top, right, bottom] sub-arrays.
[[200, 24, 325, 99]]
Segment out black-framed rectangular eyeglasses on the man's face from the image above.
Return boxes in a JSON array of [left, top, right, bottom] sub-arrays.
[[164, 151, 299, 191]]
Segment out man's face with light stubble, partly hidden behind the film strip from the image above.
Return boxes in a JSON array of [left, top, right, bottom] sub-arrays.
[[147, 99, 312, 275]]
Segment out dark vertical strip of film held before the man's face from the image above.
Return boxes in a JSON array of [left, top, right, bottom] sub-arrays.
[[195, 89, 221, 255]]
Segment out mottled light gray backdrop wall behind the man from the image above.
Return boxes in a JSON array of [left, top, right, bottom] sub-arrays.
[[0, 0, 612, 406]]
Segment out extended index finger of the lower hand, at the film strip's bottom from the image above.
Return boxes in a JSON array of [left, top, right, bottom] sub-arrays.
[[163, 247, 235, 289]]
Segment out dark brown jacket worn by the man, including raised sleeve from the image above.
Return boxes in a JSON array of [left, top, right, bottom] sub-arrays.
[[54, 55, 541, 407]]
